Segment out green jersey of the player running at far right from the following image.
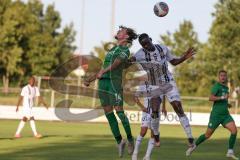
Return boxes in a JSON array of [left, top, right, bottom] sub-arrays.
[[211, 82, 229, 115]]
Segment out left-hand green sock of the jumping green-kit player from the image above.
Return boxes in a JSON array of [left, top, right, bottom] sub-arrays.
[[105, 112, 122, 144]]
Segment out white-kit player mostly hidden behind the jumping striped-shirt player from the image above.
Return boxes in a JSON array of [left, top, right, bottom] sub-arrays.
[[132, 83, 167, 160]]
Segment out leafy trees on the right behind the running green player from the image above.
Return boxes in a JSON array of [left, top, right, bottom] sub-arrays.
[[160, 0, 240, 96]]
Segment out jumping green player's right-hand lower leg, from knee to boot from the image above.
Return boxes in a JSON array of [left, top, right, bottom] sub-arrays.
[[114, 106, 134, 155]]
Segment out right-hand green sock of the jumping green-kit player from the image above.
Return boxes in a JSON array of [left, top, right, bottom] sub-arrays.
[[117, 111, 133, 142]]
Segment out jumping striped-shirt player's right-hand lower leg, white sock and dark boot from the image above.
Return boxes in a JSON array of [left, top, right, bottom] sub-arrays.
[[171, 101, 194, 146]]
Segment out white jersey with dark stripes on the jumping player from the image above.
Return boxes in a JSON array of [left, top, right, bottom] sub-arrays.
[[133, 44, 175, 85]]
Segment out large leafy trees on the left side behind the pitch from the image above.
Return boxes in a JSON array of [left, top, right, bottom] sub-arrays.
[[0, 0, 75, 92]]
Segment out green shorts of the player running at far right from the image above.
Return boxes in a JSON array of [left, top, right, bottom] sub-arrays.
[[208, 114, 234, 130]]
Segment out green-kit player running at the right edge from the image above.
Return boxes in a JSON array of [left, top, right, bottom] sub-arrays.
[[186, 70, 239, 160]]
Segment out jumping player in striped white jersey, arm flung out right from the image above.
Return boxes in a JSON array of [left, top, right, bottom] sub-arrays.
[[130, 33, 195, 146]]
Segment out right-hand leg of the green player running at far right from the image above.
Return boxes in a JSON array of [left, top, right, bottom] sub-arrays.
[[225, 121, 239, 160]]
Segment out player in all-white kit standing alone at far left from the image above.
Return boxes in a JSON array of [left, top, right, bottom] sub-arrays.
[[15, 77, 48, 138]]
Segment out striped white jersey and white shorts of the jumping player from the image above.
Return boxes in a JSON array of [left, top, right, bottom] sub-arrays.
[[134, 44, 181, 103]]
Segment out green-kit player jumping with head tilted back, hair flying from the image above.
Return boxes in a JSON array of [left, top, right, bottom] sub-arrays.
[[85, 26, 137, 157]]
